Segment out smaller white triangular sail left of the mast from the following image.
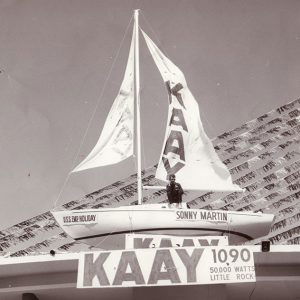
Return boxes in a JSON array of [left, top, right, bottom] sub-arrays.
[[72, 33, 134, 172]]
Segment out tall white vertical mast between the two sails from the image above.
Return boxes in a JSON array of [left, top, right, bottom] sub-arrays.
[[134, 9, 143, 204]]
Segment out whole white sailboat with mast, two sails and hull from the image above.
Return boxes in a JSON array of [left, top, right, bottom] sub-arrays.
[[52, 10, 274, 249]]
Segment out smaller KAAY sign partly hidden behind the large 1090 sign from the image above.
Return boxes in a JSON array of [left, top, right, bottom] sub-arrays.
[[125, 234, 228, 249]]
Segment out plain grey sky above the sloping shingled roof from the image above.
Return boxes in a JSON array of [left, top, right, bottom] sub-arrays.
[[0, 0, 300, 229]]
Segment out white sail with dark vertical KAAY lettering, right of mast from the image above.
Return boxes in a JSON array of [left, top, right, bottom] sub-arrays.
[[142, 31, 241, 191]]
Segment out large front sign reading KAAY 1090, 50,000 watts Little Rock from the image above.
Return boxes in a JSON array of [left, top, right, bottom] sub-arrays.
[[77, 246, 255, 288]]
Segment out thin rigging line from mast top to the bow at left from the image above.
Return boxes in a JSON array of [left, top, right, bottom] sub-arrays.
[[53, 16, 133, 209]]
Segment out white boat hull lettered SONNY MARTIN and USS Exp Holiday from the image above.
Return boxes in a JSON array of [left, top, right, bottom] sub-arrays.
[[52, 204, 274, 250]]
